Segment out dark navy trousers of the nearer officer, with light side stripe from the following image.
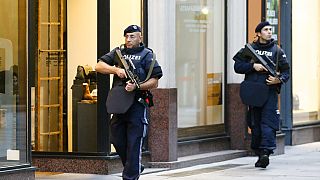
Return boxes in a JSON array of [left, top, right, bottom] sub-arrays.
[[110, 102, 148, 180]]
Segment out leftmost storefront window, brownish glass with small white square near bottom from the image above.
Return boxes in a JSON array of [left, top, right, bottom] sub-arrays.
[[0, 0, 29, 167]]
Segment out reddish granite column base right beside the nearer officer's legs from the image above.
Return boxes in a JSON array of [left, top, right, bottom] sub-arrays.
[[148, 88, 178, 162]]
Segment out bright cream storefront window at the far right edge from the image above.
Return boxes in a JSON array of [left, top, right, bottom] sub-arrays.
[[292, 0, 320, 125]]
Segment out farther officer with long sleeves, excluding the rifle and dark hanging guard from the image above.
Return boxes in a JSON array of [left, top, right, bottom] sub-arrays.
[[233, 21, 289, 168]]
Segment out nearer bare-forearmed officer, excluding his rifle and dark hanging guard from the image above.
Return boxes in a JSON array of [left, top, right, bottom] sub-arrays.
[[95, 25, 162, 180]]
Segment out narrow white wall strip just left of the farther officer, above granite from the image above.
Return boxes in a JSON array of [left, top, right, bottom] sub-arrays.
[[227, 0, 247, 84]]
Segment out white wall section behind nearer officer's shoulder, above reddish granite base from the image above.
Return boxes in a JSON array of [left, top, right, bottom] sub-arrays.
[[148, 0, 176, 88]]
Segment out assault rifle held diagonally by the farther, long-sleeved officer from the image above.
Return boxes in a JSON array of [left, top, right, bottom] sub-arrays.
[[243, 43, 284, 83]]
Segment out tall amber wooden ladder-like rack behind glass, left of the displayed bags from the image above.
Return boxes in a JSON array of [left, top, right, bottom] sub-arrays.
[[34, 0, 66, 151]]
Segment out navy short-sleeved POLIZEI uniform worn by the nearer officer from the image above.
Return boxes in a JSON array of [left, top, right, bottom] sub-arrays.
[[100, 43, 162, 179]]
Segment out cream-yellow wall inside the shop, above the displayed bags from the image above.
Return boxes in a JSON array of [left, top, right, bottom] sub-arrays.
[[67, 0, 97, 150]]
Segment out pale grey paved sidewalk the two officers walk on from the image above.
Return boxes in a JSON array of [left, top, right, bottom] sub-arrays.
[[36, 142, 320, 180]]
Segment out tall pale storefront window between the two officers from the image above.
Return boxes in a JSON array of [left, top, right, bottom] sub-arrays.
[[176, 0, 225, 134]]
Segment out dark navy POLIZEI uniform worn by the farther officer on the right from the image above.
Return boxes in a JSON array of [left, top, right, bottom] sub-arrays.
[[233, 39, 289, 165]]
